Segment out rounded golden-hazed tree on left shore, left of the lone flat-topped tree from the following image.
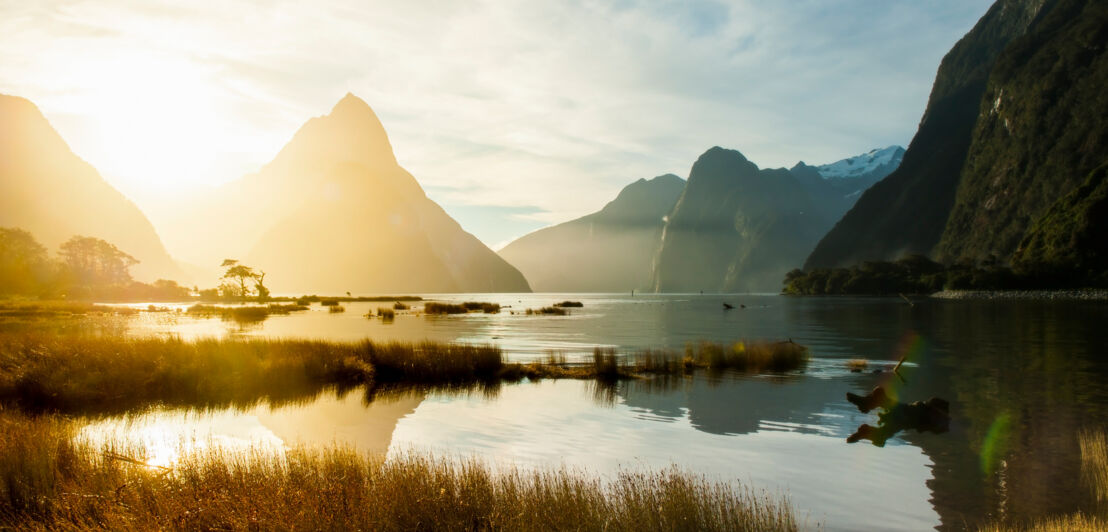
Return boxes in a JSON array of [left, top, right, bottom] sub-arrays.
[[59, 236, 139, 287]]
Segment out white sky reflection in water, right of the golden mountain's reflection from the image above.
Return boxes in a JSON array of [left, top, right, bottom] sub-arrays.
[[390, 381, 937, 530]]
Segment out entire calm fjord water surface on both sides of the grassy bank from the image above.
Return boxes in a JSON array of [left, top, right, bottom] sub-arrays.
[[83, 294, 1108, 530]]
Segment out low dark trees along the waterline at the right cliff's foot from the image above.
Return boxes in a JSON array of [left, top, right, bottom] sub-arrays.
[[782, 255, 1035, 296]]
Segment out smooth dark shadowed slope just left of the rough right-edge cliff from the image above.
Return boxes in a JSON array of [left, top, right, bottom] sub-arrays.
[[804, 0, 1043, 269]]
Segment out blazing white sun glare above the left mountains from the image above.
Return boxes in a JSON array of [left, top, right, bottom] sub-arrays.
[[51, 50, 240, 190]]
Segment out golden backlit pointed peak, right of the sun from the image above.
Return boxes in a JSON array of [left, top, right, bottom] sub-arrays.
[[214, 94, 530, 294]]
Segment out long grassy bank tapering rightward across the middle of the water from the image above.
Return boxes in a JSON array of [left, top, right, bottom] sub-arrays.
[[0, 331, 808, 412]]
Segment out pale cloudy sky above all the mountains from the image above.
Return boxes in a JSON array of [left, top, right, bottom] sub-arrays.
[[0, 0, 991, 253]]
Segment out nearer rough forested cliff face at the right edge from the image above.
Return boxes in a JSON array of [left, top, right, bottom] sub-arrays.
[[934, 0, 1108, 272]]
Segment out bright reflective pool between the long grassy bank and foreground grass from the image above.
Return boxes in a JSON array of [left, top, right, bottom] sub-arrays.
[[80, 378, 937, 530]]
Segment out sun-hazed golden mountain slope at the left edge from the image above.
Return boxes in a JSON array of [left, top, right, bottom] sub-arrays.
[[0, 94, 183, 282]]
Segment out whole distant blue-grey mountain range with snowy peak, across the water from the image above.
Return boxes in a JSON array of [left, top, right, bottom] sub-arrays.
[[500, 146, 904, 293]]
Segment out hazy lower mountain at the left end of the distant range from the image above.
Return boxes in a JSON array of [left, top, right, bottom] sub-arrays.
[[500, 174, 685, 291]]
